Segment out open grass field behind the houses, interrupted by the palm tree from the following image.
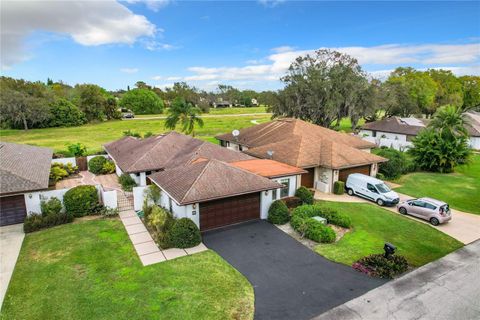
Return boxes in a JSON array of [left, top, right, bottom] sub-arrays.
[[0, 115, 270, 154]]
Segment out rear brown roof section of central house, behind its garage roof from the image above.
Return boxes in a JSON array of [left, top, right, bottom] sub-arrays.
[[104, 131, 251, 173]]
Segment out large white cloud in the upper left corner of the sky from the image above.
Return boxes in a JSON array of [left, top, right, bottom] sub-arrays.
[[0, 0, 157, 67]]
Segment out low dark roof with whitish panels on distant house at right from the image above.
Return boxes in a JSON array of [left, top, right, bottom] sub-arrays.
[[362, 117, 427, 136]]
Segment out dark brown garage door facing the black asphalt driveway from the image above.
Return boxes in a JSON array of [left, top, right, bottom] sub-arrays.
[[200, 193, 260, 231]]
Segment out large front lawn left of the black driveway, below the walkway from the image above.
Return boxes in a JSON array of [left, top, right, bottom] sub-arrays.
[[0, 220, 254, 320]]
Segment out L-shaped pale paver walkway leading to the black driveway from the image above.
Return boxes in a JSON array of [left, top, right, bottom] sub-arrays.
[[120, 210, 207, 266]]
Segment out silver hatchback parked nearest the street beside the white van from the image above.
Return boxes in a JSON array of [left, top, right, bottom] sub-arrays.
[[397, 198, 452, 226]]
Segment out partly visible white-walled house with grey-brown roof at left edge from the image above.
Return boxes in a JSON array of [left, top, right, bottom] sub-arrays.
[[0, 142, 53, 226]]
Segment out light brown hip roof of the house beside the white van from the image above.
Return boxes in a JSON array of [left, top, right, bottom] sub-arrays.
[[217, 119, 386, 169]]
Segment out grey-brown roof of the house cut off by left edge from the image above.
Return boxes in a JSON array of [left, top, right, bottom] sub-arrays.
[[0, 142, 53, 194]]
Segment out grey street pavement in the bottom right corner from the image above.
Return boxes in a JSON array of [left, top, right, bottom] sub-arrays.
[[315, 241, 480, 320]]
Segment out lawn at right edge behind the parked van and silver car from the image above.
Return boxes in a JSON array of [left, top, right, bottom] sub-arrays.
[[395, 154, 480, 214]]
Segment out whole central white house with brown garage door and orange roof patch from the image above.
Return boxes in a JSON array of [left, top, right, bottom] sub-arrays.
[[104, 131, 305, 231]]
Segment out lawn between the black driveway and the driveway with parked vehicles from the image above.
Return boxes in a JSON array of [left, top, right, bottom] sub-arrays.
[[315, 202, 463, 267]]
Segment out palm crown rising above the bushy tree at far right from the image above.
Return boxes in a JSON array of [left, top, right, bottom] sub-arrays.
[[429, 105, 468, 137]]
